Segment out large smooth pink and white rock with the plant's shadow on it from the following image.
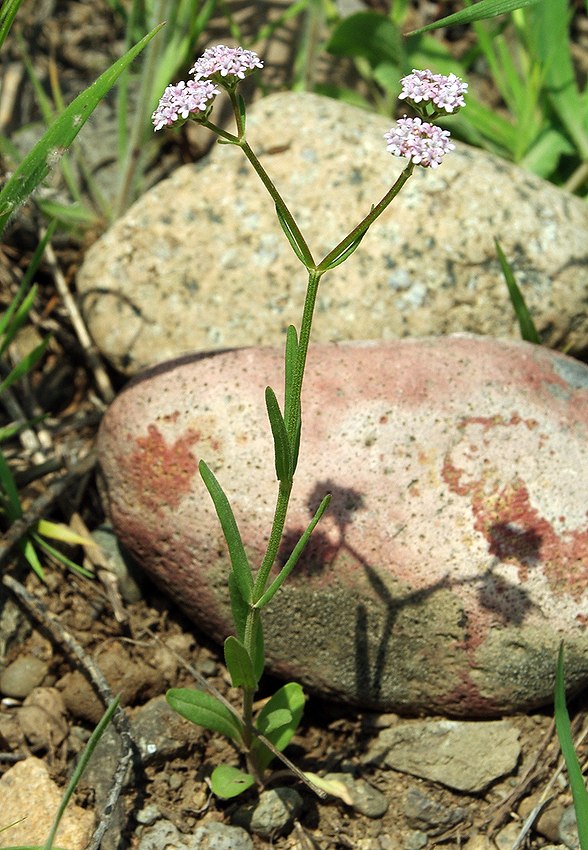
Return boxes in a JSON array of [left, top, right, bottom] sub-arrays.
[[99, 336, 588, 716]]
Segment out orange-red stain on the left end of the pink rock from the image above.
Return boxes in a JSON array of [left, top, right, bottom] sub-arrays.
[[124, 425, 201, 511]]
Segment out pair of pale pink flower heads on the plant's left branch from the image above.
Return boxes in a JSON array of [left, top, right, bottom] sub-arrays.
[[151, 44, 263, 130]]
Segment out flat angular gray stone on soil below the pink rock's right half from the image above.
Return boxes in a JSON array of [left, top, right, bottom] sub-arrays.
[[365, 720, 521, 794]]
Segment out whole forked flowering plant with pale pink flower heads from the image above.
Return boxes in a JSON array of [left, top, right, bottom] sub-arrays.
[[152, 45, 467, 798]]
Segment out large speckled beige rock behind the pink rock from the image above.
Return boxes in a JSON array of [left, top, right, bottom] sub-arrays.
[[78, 93, 588, 374]]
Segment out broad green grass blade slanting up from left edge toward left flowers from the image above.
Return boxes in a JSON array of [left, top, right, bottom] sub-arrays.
[[0, 24, 163, 233]]
